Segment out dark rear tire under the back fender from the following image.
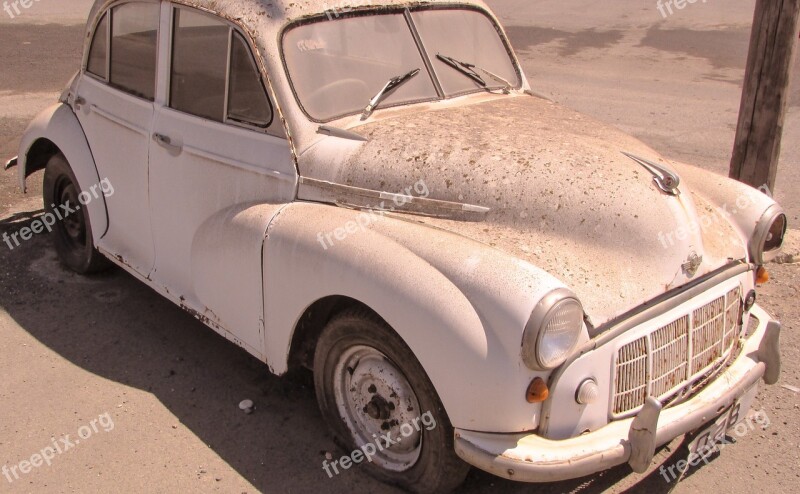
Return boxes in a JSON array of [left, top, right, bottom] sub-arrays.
[[42, 153, 110, 274]]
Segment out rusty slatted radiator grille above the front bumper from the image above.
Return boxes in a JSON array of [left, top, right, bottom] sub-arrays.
[[611, 288, 742, 417]]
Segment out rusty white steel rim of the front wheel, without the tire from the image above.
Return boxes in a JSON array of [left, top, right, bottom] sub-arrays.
[[333, 345, 422, 472]]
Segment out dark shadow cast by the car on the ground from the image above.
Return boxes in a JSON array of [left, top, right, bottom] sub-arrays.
[[0, 221, 704, 493]]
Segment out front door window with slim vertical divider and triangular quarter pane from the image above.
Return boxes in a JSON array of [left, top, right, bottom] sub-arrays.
[[169, 8, 272, 128]]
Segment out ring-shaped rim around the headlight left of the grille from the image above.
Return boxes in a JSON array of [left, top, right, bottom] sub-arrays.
[[522, 288, 584, 371]]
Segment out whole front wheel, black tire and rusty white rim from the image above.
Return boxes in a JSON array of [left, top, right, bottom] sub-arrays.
[[314, 309, 469, 492]]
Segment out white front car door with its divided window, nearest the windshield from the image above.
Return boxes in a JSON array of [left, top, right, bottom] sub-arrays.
[[149, 3, 297, 352]]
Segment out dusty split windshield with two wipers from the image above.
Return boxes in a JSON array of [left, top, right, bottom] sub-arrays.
[[283, 9, 519, 122]]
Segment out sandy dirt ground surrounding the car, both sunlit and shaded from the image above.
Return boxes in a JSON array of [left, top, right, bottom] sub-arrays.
[[0, 0, 800, 493]]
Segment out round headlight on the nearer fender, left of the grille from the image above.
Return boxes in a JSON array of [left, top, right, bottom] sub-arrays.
[[522, 288, 583, 370]]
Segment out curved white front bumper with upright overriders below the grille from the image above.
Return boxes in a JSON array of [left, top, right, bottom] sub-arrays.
[[455, 306, 780, 482]]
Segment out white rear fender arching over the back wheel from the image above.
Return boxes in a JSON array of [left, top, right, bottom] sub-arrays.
[[17, 103, 108, 242]]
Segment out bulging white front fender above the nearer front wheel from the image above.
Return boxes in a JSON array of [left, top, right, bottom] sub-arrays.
[[264, 203, 576, 432]]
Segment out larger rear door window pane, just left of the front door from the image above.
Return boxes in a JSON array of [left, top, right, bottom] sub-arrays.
[[109, 3, 160, 101]]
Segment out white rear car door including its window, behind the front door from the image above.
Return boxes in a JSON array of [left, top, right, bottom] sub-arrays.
[[75, 2, 160, 275]]
